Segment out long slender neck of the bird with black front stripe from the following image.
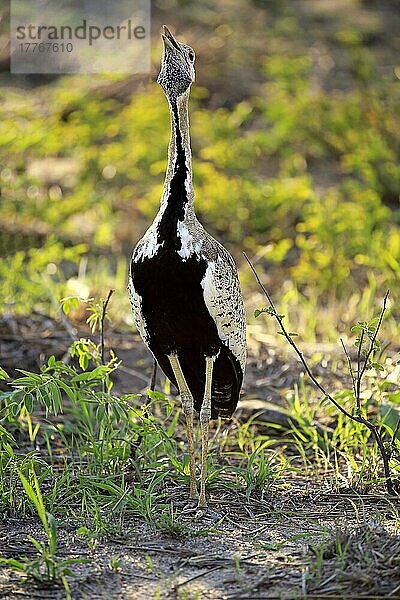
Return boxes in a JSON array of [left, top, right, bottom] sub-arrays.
[[161, 92, 194, 214]]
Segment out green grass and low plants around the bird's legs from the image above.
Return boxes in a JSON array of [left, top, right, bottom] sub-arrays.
[[0, 292, 400, 596]]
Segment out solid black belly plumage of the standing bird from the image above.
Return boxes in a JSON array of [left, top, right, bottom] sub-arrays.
[[131, 249, 243, 419]]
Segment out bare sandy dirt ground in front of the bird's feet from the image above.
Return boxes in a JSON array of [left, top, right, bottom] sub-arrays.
[[0, 488, 400, 599]]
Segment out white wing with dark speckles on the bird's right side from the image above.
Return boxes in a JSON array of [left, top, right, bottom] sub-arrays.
[[201, 247, 246, 373]]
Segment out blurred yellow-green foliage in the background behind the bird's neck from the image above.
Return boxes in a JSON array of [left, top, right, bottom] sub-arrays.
[[0, 2, 400, 332]]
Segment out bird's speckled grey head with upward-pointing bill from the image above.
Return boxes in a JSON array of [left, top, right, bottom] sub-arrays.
[[157, 25, 195, 102]]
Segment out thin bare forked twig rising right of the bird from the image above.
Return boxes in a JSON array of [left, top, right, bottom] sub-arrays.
[[243, 252, 400, 495]]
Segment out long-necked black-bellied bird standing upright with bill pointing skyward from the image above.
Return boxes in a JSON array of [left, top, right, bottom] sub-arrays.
[[128, 25, 247, 509]]
